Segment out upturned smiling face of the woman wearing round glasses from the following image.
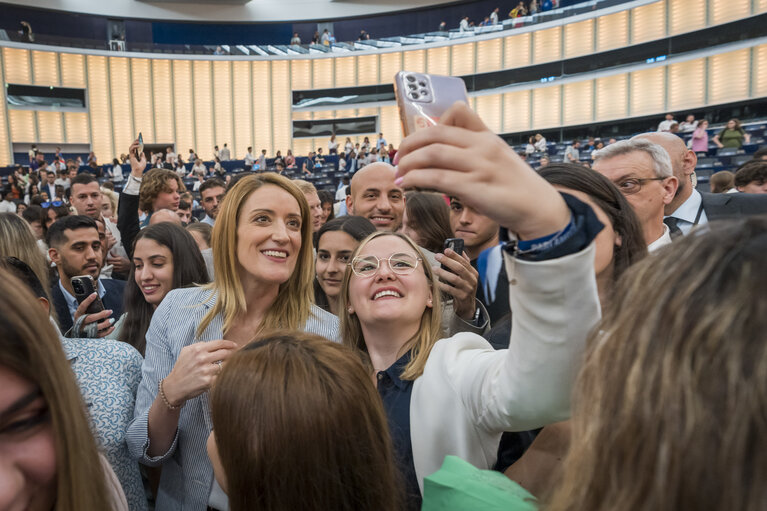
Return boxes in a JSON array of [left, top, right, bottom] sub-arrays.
[[348, 236, 432, 330]]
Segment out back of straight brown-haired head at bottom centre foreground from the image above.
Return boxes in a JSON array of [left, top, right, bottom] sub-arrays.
[[208, 332, 401, 511]]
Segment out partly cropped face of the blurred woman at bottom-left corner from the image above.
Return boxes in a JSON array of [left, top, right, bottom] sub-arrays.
[[0, 366, 57, 511]]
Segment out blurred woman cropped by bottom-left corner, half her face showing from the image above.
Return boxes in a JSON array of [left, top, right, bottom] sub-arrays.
[[0, 270, 128, 511]]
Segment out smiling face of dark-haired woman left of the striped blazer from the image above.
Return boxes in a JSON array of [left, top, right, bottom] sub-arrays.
[[133, 238, 173, 307]]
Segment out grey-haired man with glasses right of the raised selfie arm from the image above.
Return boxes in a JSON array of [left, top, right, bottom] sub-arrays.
[[594, 138, 679, 251]]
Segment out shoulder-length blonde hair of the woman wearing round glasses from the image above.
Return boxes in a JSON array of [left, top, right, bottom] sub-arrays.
[[339, 232, 442, 380]]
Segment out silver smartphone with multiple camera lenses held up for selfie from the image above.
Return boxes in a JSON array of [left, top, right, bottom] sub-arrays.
[[394, 71, 469, 136]]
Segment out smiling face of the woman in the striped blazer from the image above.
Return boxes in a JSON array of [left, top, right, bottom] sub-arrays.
[[237, 185, 301, 285]]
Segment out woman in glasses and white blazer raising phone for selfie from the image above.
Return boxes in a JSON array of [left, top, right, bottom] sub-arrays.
[[340, 103, 602, 508]]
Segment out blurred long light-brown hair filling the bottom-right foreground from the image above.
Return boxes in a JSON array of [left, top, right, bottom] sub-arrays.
[[547, 217, 767, 511]]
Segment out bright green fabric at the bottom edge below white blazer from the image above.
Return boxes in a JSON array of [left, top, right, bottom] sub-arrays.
[[421, 456, 538, 511]]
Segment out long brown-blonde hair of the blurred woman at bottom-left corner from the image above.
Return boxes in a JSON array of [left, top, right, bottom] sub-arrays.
[[0, 269, 112, 511]]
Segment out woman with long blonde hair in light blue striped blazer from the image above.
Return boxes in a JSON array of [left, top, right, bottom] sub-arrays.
[[127, 174, 339, 510]]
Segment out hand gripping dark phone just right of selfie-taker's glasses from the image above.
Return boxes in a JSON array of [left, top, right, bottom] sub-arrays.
[[434, 248, 479, 321]]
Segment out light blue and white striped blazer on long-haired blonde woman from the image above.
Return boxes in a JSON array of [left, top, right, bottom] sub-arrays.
[[126, 288, 340, 511]]
